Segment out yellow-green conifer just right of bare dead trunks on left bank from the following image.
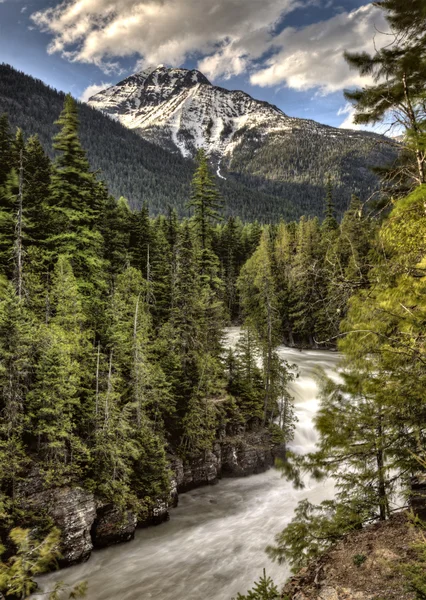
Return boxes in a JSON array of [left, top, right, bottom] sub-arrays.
[[104, 268, 174, 510]]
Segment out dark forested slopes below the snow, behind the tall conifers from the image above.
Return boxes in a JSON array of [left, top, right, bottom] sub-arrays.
[[0, 64, 394, 222]]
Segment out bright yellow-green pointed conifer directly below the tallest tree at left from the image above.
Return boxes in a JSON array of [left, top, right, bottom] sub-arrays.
[[28, 256, 92, 481]]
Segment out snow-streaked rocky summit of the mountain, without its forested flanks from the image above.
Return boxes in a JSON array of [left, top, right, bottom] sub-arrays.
[[89, 65, 300, 157]]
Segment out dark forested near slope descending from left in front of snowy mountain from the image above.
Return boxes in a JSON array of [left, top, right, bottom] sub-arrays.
[[0, 64, 292, 222]]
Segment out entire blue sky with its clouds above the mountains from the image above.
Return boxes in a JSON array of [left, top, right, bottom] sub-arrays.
[[0, 0, 385, 126]]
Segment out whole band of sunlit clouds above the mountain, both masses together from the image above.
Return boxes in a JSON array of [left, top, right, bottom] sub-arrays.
[[31, 0, 388, 94]]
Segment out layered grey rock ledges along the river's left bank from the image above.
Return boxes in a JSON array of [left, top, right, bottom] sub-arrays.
[[20, 431, 280, 566]]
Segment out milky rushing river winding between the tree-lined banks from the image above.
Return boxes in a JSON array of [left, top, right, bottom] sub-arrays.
[[35, 328, 338, 600]]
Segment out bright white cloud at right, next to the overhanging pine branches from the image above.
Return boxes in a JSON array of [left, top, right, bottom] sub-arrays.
[[251, 4, 388, 94]]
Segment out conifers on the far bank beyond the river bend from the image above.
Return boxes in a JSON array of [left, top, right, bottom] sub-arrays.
[[239, 182, 378, 348]]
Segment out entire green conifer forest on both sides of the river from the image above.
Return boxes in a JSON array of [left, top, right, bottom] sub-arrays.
[[0, 0, 426, 600]]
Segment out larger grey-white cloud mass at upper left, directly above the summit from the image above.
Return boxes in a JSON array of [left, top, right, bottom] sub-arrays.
[[32, 0, 300, 73]]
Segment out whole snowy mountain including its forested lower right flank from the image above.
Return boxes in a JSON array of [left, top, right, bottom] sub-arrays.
[[89, 66, 397, 216]]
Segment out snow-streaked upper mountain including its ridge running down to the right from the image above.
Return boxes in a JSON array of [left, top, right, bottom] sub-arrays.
[[89, 65, 388, 180]]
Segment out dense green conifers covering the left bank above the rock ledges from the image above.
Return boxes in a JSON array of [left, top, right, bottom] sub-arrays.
[[0, 96, 298, 548]]
